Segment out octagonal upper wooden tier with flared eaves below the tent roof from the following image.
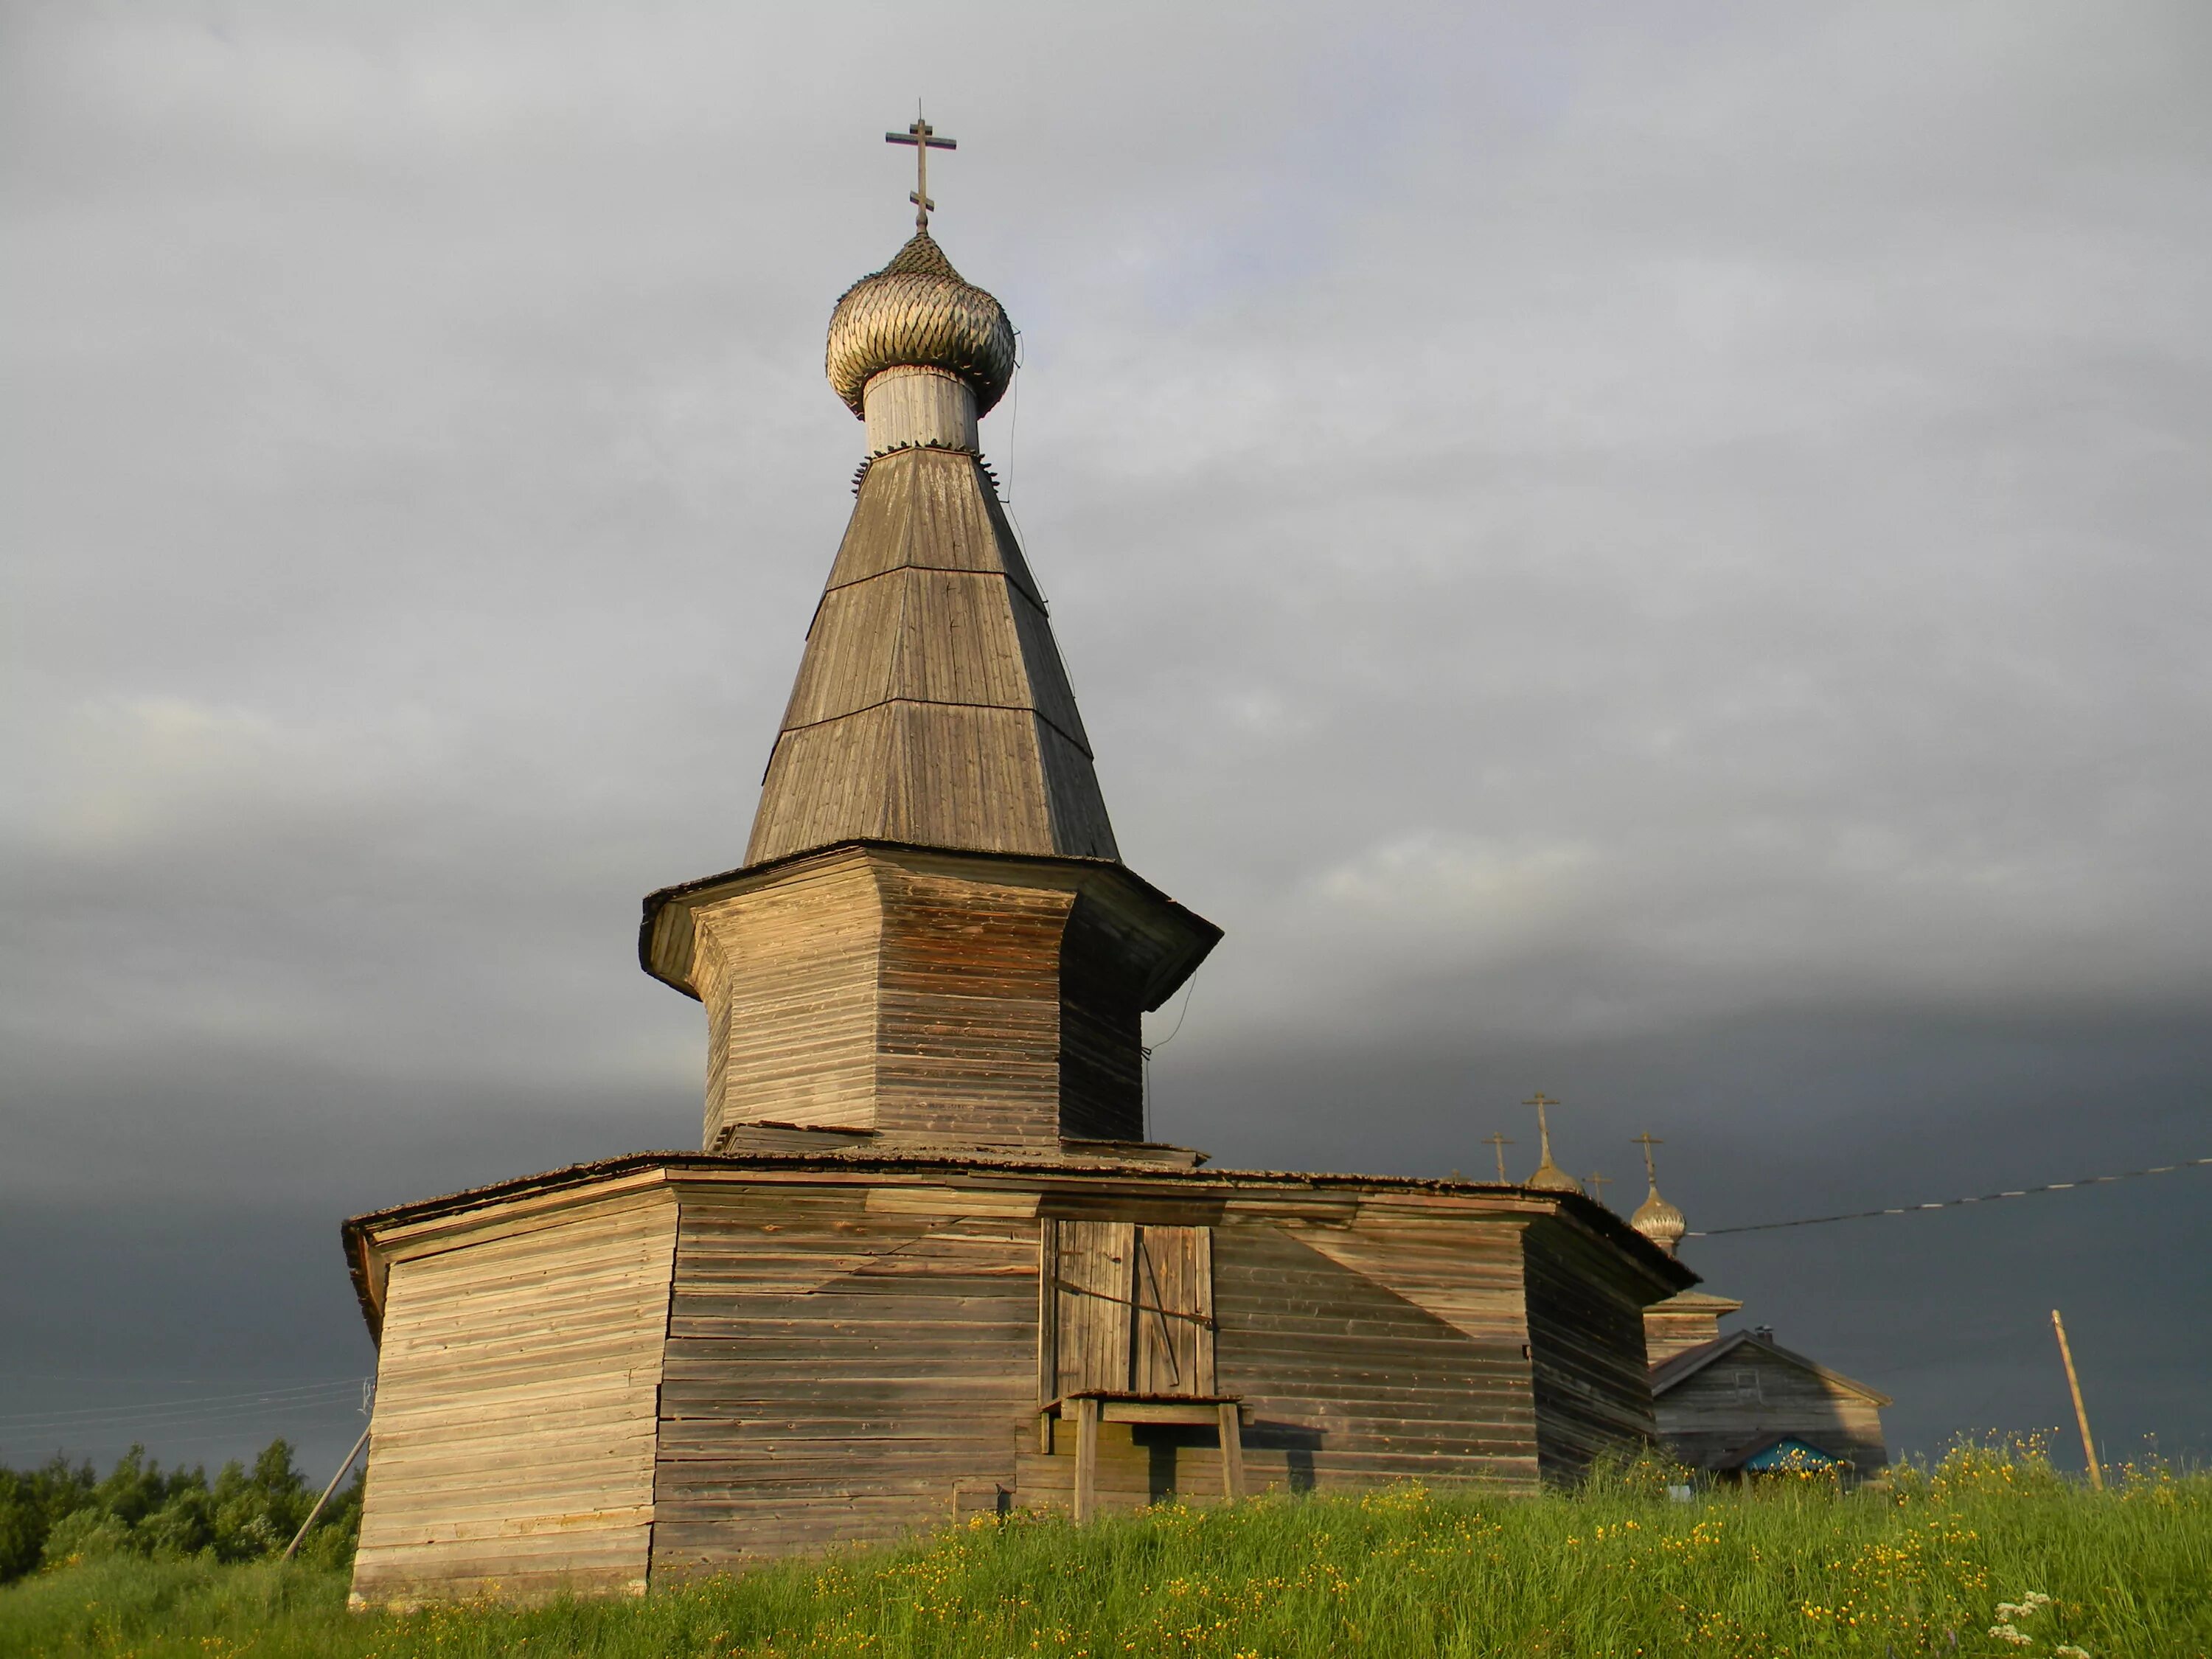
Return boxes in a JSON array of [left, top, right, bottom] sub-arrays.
[[641, 843, 1221, 1152]]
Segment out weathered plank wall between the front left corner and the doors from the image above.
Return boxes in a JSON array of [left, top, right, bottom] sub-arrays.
[[655, 1186, 1037, 1575]]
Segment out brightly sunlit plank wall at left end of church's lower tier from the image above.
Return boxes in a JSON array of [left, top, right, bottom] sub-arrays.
[[354, 1190, 677, 1606]]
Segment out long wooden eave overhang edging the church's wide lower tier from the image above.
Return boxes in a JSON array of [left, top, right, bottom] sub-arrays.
[[341, 1150, 1690, 1354]]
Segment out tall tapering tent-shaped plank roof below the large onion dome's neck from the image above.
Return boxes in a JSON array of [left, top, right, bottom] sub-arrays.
[[745, 447, 1117, 865]]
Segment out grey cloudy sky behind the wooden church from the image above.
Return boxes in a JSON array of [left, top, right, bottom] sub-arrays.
[[0, 0, 2212, 1462]]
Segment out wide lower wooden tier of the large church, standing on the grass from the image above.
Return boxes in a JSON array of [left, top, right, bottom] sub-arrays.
[[349, 1152, 1688, 1604]]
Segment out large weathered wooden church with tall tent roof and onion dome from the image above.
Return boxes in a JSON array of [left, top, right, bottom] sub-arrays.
[[345, 122, 1694, 1606]]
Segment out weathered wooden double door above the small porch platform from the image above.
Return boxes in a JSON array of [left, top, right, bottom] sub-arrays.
[[1037, 1221, 1214, 1400]]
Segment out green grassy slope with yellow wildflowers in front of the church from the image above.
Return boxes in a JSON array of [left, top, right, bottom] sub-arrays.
[[0, 1451, 2212, 1659]]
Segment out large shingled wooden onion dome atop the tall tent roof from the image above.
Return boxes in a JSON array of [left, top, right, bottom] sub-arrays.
[[827, 230, 1013, 418]]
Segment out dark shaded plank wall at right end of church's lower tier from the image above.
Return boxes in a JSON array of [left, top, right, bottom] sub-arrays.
[[1522, 1219, 1657, 1482]]
